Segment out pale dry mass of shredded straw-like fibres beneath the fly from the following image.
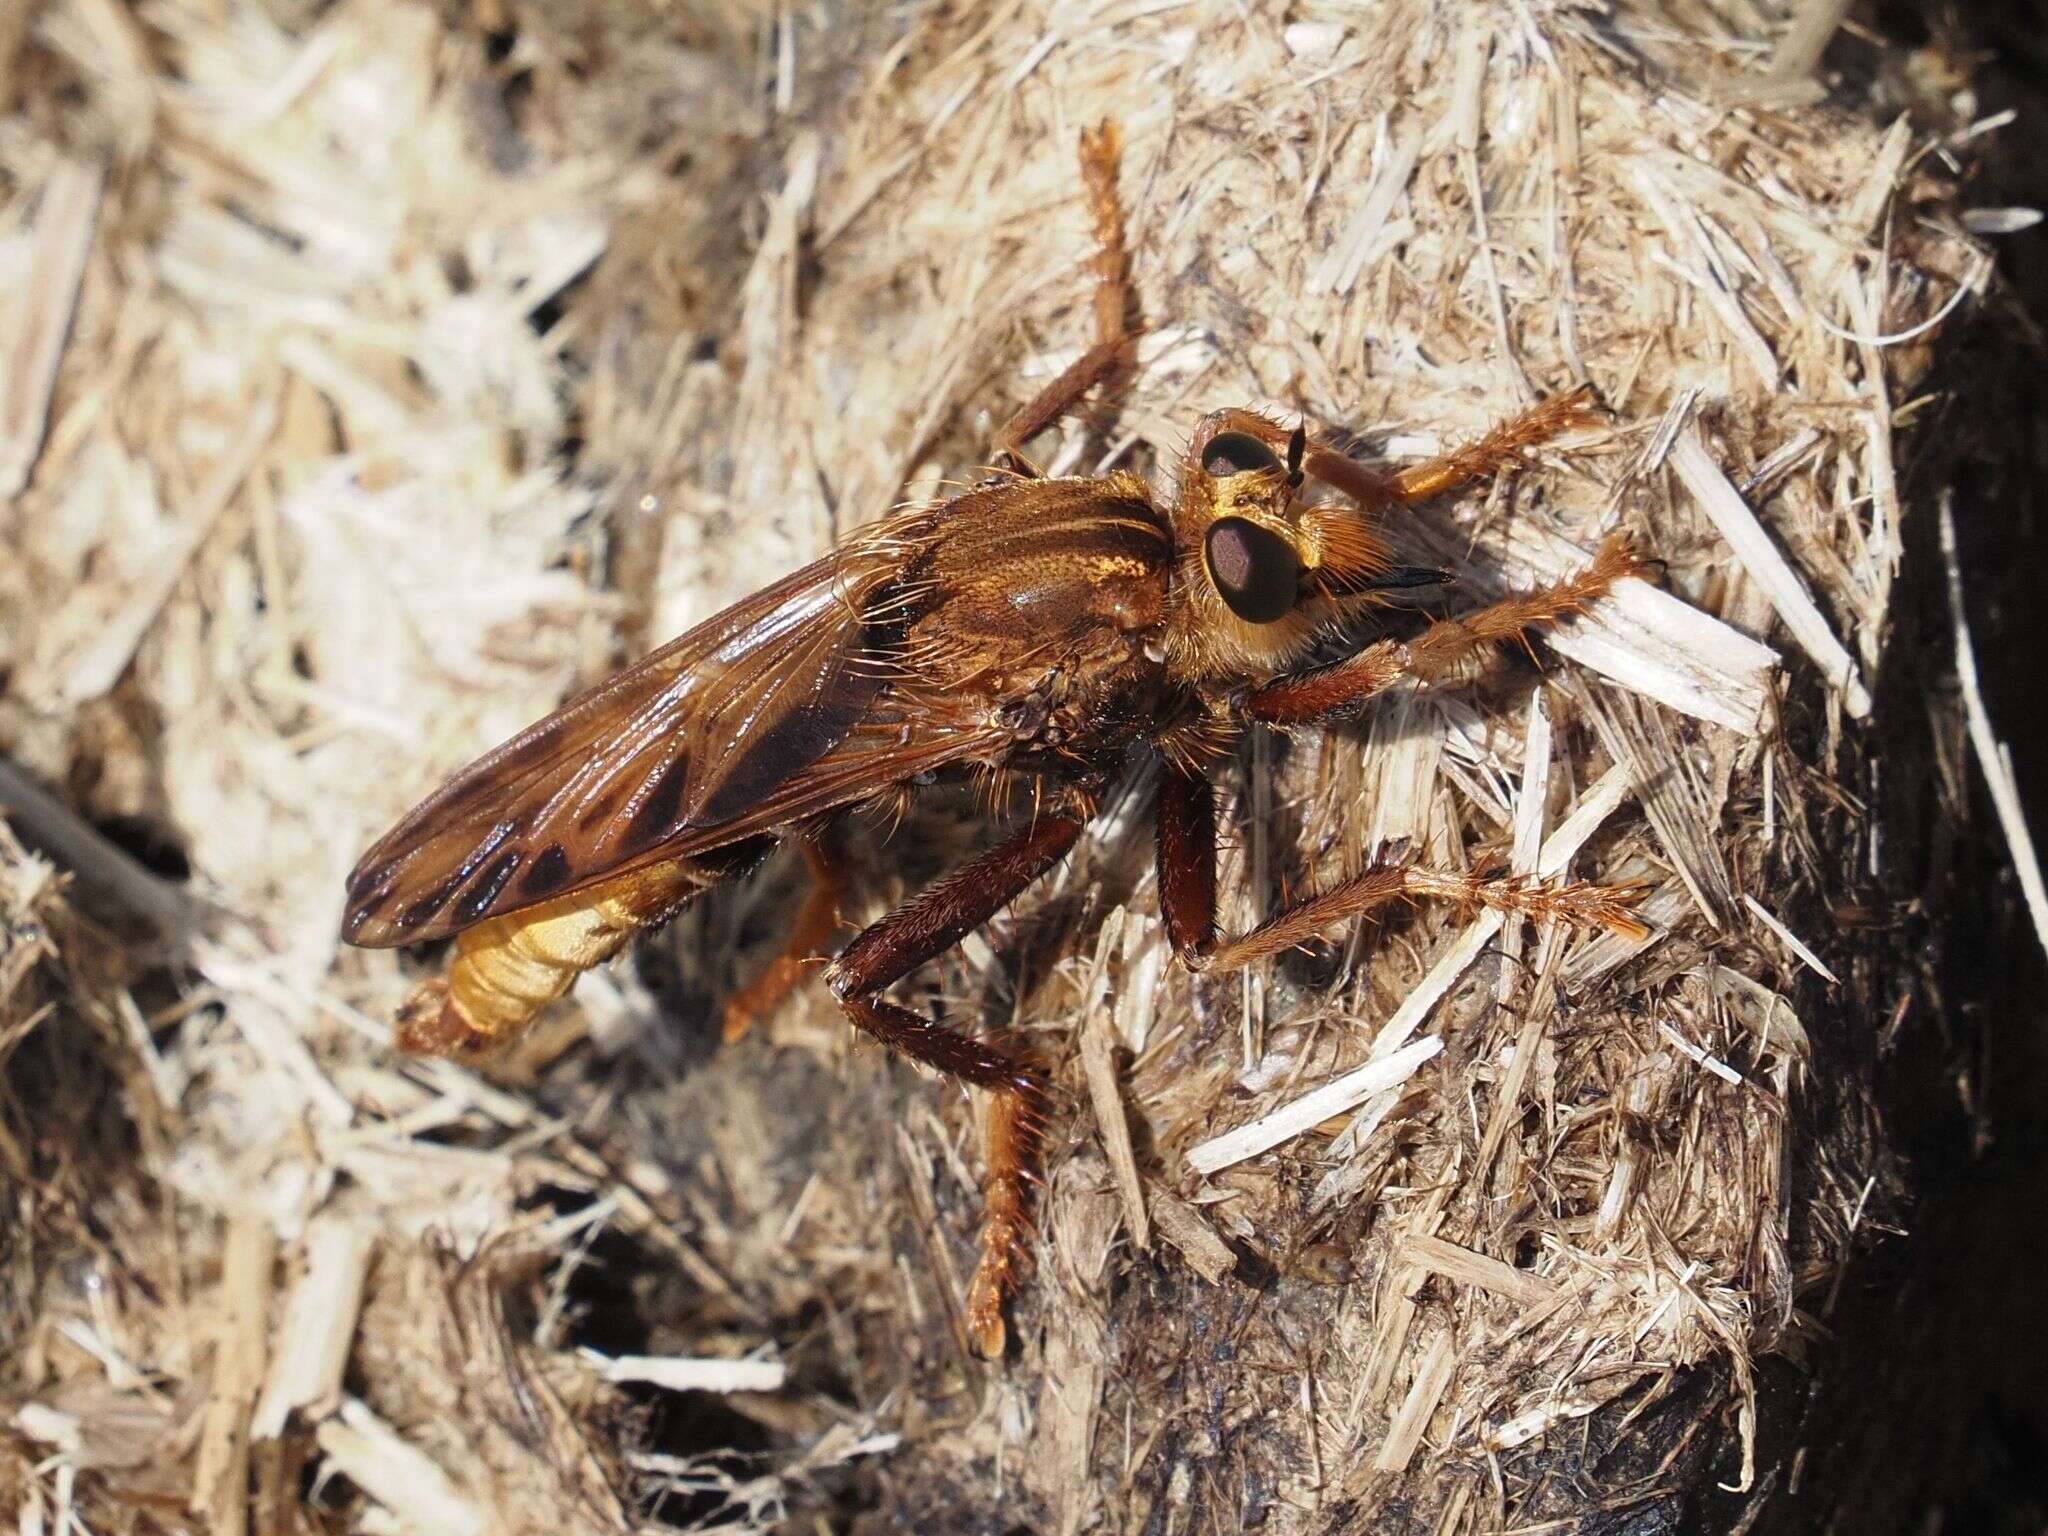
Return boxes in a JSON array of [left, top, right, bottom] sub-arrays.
[[0, 0, 1987, 1532]]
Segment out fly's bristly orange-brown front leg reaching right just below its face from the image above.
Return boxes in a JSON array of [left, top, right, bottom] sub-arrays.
[[1243, 539, 1642, 725]]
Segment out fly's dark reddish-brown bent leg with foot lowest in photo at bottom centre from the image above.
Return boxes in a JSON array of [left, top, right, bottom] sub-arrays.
[[825, 811, 1087, 1360]]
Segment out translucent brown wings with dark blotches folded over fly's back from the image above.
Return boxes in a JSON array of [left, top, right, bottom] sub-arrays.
[[342, 549, 993, 946]]
